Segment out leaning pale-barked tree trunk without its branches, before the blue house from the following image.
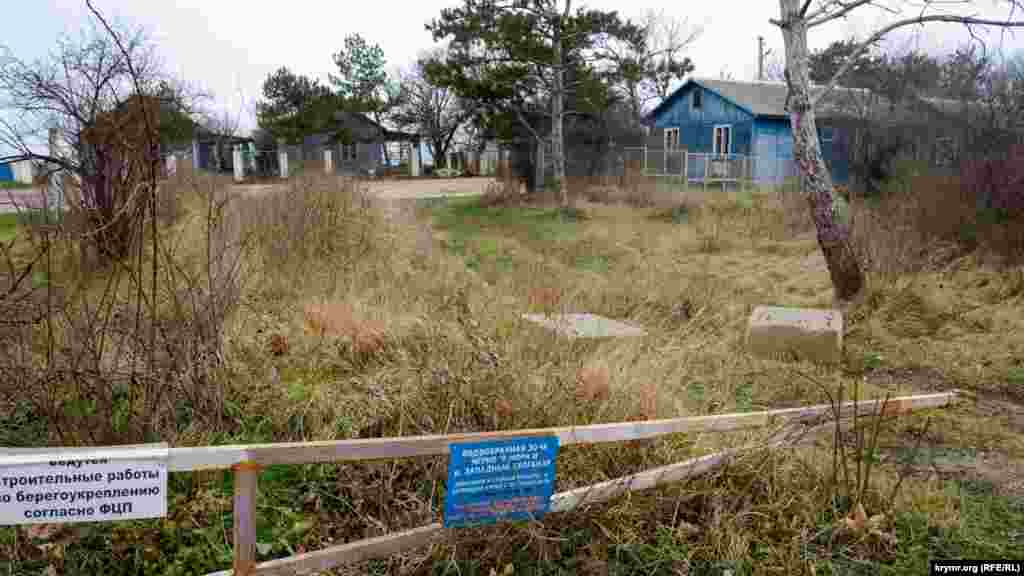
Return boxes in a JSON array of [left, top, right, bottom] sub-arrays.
[[779, 0, 864, 300]]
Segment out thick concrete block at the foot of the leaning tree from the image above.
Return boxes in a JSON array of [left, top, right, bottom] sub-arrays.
[[746, 306, 843, 364]]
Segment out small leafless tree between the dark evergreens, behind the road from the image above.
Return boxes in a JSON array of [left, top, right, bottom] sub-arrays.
[[394, 49, 471, 166]]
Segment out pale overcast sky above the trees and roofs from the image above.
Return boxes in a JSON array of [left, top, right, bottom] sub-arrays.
[[0, 0, 1024, 139]]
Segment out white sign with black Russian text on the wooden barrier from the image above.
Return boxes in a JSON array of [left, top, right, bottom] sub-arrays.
[[0, 445, 168, 526]]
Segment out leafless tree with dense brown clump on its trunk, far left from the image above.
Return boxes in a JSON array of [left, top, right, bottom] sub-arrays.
[[0, 17, 197, 259]]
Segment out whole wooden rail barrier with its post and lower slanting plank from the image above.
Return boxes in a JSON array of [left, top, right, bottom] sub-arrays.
[[0, 390, 957, 576]]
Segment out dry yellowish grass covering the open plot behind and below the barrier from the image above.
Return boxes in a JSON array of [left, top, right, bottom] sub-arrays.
[[2, 168, 1024, 574]]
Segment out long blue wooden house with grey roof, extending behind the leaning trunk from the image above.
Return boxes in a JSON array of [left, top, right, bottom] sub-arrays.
[[644, 79, 1011, 189]]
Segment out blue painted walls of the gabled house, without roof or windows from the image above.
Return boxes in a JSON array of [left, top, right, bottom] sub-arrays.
[[653, 83, 849, 183]]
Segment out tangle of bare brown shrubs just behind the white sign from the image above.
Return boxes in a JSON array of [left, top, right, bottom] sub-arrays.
[[0, 171, 246, 445]]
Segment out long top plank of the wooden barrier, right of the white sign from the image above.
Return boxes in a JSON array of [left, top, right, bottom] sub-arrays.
[[168, 392, 956, 471]]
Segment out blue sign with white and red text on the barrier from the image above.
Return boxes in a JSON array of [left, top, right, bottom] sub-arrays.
[[444, 436, 558, 528]]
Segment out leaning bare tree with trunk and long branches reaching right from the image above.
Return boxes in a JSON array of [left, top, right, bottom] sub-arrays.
[[771, 0, 1024, 300]]
